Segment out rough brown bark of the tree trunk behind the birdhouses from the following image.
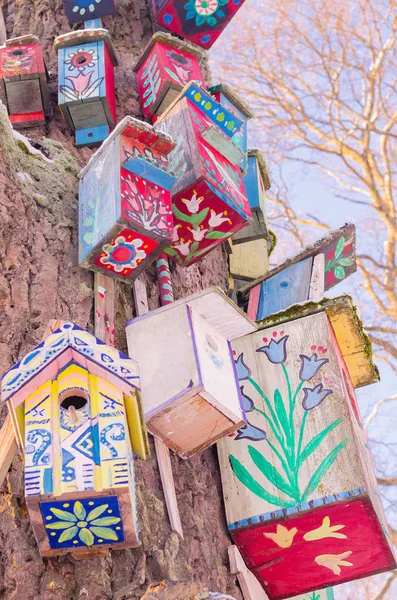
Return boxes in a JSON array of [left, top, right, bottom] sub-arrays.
[[0, 0, 241, 600]]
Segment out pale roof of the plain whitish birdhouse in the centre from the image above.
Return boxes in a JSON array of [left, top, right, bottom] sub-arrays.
[[127, 286, 256, 341]]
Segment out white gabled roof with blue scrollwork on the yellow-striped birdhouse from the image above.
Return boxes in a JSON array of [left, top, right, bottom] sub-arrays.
[[1, 321, 140, 406]]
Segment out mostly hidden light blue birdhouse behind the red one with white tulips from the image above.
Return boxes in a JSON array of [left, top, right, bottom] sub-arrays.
[[208, 84, 255, 173]]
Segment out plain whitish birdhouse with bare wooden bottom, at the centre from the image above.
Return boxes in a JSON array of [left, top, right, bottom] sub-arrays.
[[127, 288, 255, 458]]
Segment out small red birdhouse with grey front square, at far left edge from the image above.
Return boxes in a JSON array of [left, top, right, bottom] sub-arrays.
[[0, 35, 49, 129]]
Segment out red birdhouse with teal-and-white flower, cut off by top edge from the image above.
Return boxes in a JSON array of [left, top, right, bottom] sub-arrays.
[[150, 0, 245, 48]]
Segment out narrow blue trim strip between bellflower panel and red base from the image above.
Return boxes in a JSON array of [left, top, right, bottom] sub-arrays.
[[227, 486, 367, 531]]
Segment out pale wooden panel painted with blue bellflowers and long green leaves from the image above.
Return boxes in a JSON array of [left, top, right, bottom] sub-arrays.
[[220, 313, 365, 530]]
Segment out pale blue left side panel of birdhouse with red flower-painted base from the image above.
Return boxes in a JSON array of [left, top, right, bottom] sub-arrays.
[[79, 138, 121, 267]]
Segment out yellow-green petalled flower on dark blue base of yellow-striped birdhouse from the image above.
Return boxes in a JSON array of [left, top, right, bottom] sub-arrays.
[[46, 500, 121, 546]]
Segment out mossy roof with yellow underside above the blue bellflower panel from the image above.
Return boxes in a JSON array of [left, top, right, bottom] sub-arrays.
[[257, 295, 379, 388]]
